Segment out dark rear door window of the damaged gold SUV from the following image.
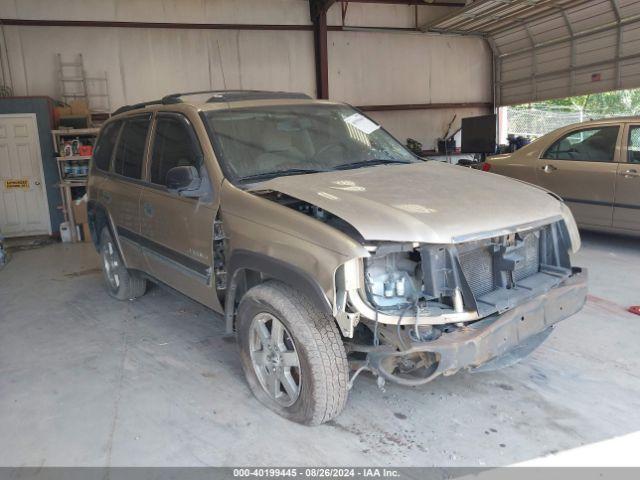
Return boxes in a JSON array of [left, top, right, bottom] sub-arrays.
[[113, 116, 151, 179]]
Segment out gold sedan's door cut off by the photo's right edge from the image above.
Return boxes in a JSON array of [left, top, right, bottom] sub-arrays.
[[613, 125, 640, 231]]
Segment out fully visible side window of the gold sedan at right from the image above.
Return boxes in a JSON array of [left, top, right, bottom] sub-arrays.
[[542, 125, 620, 162]]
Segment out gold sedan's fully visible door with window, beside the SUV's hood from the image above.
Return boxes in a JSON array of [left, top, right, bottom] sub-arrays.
[[537, 125, 620, 227]]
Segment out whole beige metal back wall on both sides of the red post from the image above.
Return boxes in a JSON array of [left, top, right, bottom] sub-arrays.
[[0, 0, 492, 148]]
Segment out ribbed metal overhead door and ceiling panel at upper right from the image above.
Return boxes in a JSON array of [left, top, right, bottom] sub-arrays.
[[423, 0, 640, 105]]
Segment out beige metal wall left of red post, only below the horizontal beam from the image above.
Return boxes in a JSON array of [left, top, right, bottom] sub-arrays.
[[4, 26, 315, 106]]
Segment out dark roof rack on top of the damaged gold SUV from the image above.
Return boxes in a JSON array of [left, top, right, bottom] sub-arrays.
[[113, 90, 311, 115]]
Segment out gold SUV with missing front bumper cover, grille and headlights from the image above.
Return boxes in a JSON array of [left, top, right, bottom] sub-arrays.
[[88, 91, 587, 424]]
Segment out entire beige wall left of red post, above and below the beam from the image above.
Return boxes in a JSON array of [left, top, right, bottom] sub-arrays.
[[0, 0, 315, 106]]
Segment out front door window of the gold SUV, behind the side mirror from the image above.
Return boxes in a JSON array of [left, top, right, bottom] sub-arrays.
[[150, 115, 202, 185]]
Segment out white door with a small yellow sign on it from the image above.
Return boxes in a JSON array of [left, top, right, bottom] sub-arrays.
[[0, 113, 51, 237]]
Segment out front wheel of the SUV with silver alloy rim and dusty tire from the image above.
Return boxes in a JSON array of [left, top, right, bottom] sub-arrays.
[[237, 281, 349, 425]]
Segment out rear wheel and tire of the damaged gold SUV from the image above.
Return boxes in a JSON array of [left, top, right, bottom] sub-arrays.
[[100, 227, 147, 300]]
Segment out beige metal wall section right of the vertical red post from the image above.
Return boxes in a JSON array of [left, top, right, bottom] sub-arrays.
[[327, 2, 493, 149]]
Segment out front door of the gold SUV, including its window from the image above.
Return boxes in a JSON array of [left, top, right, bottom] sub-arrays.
[[141, 113, 221, 311]]
